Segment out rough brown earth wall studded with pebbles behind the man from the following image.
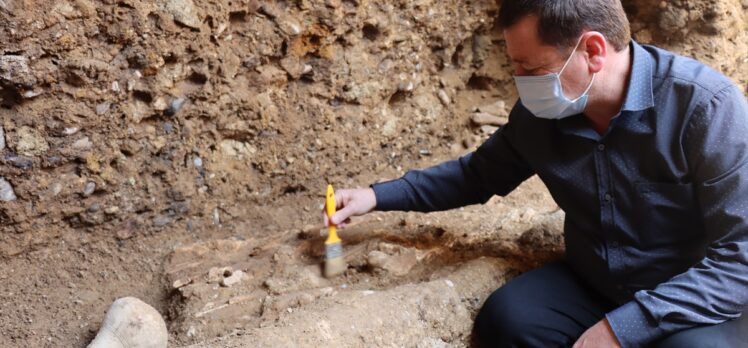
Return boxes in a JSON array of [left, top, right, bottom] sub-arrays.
[[0, 0, 748, 255]]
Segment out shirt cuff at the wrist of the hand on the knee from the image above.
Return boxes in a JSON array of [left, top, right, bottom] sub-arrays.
[[605, 301, 664, 348]]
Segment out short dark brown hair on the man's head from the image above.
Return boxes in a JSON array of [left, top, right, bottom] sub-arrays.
[[498, 0, 631, 51]]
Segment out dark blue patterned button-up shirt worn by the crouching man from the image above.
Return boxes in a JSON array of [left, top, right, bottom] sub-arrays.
[[373, 42, 748, 347]]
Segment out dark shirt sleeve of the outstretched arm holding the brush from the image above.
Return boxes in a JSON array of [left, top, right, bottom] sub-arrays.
[[372, 108, 533, 212]]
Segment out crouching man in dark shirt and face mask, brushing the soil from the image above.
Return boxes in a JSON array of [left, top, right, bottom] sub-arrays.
[[332, 0, 748, 348]]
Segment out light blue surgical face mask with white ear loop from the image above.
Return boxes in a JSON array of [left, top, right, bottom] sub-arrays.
[[514, 37, 596, 119]]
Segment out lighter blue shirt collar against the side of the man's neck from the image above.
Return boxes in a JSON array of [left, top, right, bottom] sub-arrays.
[[621, 40, 654, 111]]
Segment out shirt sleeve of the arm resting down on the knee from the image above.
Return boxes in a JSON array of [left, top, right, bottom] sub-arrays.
[[607, 85, 748, 347]]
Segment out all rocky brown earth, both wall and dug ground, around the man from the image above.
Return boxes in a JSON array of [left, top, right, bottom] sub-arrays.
[[0, 0, 748, 347]]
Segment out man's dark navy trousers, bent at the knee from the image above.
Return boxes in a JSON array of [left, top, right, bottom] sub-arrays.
[[475, 262, 748, 348]]
